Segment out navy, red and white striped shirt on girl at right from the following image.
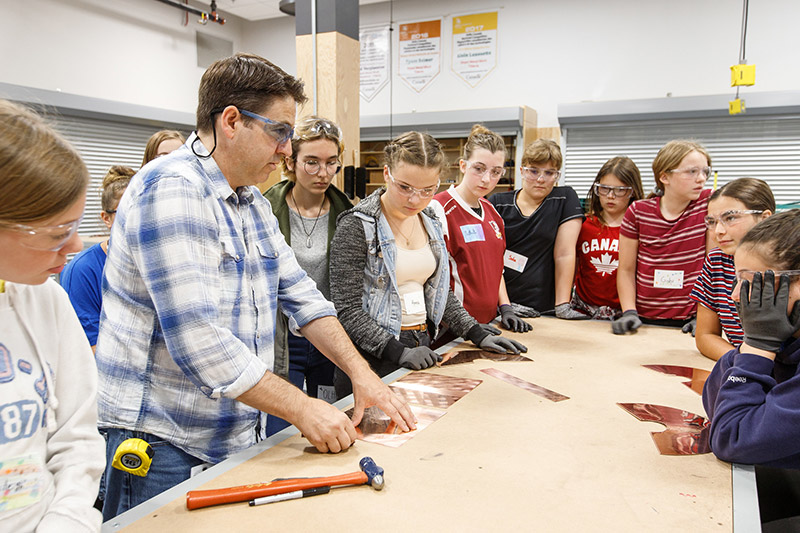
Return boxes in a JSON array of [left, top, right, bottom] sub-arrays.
[[689, 248, 744, 347]]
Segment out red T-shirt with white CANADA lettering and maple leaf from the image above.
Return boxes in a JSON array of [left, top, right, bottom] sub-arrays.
[[575, 216, 619, 309]]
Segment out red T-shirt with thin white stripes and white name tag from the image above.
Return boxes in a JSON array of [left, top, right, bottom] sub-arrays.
[[620, 189, 711, 320]]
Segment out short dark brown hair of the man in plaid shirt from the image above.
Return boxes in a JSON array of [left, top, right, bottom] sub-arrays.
[[197, 54, 306, 132]]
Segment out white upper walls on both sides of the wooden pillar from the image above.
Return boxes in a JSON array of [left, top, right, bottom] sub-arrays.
[[0, 0, 800, 127]]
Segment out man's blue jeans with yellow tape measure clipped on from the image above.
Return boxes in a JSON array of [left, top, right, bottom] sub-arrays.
[[103, 428, 205, 522]]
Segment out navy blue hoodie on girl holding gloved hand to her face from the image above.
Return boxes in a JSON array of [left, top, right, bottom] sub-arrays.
[[703, 339, 800, 468]]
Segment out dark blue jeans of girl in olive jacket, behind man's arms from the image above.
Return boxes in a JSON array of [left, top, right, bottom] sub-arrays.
[[266, 332, 336, 437]]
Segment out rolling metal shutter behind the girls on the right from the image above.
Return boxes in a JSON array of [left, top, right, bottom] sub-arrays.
[[563, 115, 800, 204]]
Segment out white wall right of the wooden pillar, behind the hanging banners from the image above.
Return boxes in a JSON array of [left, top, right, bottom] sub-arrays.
[[360, 0, 800, 127]]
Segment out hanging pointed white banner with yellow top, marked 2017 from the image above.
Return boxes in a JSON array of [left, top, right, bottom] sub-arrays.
[[452, 11, 497, 87]]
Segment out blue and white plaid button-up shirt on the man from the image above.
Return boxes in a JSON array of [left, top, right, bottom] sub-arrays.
[[96, 135, 335, 463]]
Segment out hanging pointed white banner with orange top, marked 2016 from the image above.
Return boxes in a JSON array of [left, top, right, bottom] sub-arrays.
[[397, 20, 442, 92]]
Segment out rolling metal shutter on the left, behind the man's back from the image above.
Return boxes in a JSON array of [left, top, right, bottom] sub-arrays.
[[48, 115, 191, 237]]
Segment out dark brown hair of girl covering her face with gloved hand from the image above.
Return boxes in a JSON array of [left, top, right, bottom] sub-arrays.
[[739, 209, 800, 270]]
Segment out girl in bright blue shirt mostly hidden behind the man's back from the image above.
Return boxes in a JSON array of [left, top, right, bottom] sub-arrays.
[[60, 165, 136, 350]]
